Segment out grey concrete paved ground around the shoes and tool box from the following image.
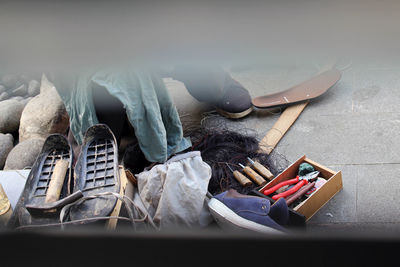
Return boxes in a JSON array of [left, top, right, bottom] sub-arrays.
[[166, 59, 400, 234]]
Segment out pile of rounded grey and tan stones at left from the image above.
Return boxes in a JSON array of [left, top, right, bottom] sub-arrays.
[[0, 74, 69, 170]]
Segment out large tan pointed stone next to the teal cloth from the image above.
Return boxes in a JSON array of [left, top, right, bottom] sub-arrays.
[[19, 75, 69, 141]]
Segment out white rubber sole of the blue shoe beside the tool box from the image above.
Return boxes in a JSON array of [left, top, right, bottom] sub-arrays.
[[208, 198, 286, 235]]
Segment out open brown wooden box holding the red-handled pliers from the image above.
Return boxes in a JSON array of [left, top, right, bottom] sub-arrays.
[[259, 155, 343, 221]]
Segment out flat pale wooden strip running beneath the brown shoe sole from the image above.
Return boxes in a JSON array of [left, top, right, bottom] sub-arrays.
[[260, 101, 308, 154]]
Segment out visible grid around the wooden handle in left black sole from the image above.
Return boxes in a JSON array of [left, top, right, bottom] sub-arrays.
[[33, 149, 70, 197]]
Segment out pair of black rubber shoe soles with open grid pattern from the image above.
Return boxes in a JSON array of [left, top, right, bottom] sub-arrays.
[[10, 124, 120, 228]]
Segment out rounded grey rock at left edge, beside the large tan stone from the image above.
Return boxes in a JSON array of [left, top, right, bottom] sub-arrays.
[[0, 99, 24, 133]]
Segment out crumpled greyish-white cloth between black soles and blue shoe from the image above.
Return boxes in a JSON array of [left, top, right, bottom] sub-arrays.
[[136, 151, 212, 229]]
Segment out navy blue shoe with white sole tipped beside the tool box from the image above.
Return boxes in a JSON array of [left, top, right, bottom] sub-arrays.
[[208, 189, 289, 234]]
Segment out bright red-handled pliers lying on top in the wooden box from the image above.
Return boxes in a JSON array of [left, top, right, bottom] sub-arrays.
[[263, 171, 319, 200]]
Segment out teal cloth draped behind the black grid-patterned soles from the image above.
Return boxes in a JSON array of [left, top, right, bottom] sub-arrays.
[[56, 70, 191, 163]]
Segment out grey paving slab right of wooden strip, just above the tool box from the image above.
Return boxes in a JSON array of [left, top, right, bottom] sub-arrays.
[[277, 112, 400, 165]]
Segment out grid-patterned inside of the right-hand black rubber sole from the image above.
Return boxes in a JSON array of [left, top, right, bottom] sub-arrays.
[[83, 139, 115, 191]]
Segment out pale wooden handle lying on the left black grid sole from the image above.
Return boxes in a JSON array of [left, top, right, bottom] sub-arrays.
[[45, 159, 69, 203]]
